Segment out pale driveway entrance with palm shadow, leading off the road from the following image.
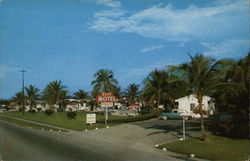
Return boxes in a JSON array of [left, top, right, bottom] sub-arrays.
[[84, 119, 204, 147]]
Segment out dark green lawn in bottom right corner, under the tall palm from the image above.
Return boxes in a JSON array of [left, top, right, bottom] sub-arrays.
[[159, 135, 249, 161]]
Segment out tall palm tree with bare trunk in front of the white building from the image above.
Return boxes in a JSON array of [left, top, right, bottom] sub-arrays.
[[173, 54, 236, 141]]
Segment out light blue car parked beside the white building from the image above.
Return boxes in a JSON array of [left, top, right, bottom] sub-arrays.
[[160, 109, 192, 120]]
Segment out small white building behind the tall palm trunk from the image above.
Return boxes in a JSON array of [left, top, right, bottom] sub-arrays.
[[175, 95, 215, 117]]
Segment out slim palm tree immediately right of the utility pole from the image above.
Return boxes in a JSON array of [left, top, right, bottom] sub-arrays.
[[25, 85, 39, 111]]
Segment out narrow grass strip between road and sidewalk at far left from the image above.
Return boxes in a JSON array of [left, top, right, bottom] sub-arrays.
[[0, 116, 67, 132]]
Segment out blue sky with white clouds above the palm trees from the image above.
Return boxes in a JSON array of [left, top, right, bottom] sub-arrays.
[[0, 0, 250, 99]]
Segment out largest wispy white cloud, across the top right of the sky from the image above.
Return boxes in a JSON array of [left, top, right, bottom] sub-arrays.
[[89, 0, 249, 41]]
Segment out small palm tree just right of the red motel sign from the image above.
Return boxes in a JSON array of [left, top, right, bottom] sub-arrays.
[[124, 83, 140, 104]]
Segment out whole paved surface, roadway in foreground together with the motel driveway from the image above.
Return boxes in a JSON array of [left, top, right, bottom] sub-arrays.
[[0, 117, 210, 161]]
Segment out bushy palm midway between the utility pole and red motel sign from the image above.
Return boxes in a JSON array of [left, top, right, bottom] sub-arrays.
[[43, 80, 66, 108]]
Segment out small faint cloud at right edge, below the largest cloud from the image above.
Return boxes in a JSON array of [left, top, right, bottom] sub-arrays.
[[201, 39, 250, 58]]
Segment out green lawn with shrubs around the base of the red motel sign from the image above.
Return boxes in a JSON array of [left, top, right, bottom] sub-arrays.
[[1, 111, 158, 131]]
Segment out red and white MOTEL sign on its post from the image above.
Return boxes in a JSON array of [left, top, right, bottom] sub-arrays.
[[96, 92, 117, 125]]
